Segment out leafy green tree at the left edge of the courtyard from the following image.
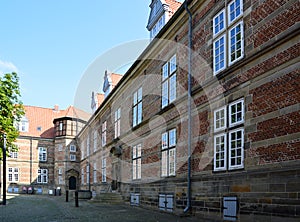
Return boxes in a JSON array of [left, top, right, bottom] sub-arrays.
[[0, 72, 25, 159]]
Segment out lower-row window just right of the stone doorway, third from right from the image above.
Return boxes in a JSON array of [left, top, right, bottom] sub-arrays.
[[132, 144, 142, 180]]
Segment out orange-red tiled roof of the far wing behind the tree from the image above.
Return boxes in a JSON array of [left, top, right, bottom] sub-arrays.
[[20, 105, 90, 138]]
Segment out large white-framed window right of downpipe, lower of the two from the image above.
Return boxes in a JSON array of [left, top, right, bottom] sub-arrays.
[[214, 99, 244, 171]]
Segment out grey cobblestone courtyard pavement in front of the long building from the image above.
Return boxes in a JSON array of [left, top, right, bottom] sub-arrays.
[[0, 195, 211, 222]]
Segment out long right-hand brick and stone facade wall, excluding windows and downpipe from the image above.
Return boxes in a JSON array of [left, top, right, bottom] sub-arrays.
[[79, 0, 300, 218]]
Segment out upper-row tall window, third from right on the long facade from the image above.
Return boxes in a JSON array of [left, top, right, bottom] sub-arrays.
[[132, 87, 143, 127]]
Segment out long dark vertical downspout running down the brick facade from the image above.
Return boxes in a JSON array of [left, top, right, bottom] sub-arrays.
[[184, 0, 193, 213]]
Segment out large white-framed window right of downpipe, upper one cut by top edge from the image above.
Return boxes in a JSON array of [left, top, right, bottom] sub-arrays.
[[213, 0, 244, 74]]
